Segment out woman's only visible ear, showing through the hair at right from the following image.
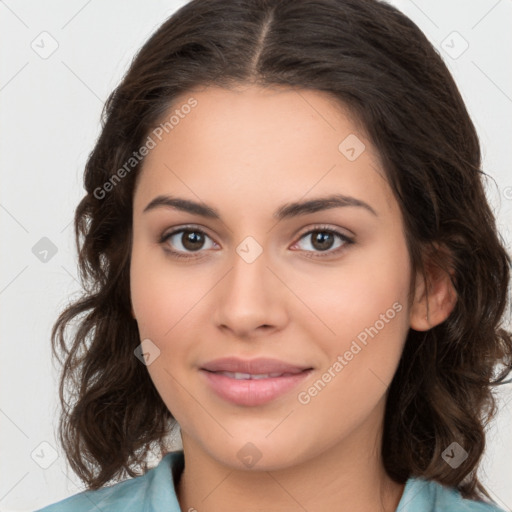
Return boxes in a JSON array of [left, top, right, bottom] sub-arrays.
[[409, 247, 457, 331]]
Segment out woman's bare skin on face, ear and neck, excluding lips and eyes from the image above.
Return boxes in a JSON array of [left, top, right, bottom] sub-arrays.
[[130, 86, 455, 512]]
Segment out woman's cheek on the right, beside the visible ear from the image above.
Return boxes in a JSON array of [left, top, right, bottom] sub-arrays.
[[298, 230, 410, 386]]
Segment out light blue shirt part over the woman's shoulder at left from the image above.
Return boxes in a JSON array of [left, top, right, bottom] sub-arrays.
[[35, 452, 183, 512]]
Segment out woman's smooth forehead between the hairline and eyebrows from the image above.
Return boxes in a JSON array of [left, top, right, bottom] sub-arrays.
[[135, 86, 392, 217]]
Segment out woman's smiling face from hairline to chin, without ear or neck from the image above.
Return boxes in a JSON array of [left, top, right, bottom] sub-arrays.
[[130, 86, 411, 469]]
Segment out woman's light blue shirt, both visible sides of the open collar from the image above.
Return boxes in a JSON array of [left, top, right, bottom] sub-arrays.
[[35, 450, 505, 512]]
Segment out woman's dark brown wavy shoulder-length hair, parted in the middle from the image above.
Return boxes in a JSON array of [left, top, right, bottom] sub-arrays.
[[51, 0, 512, 500]]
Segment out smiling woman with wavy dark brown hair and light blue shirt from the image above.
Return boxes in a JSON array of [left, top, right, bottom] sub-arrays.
[[37, 0, 512, 512]]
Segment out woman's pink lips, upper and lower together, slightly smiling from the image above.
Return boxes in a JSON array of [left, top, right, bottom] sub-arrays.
[[200, 358, 313, 407]]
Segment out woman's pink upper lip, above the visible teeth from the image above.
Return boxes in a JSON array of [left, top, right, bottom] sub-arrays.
[[201, 357, 311, 375]]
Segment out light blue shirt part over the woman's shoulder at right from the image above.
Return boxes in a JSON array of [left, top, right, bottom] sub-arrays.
[[396, 477, 505, 512]]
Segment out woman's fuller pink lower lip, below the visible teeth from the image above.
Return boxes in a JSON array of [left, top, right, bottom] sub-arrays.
[[201, 370, 312, 406]]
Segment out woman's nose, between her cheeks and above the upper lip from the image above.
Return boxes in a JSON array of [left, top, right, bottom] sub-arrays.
[[214, 244, 291, 339]]
